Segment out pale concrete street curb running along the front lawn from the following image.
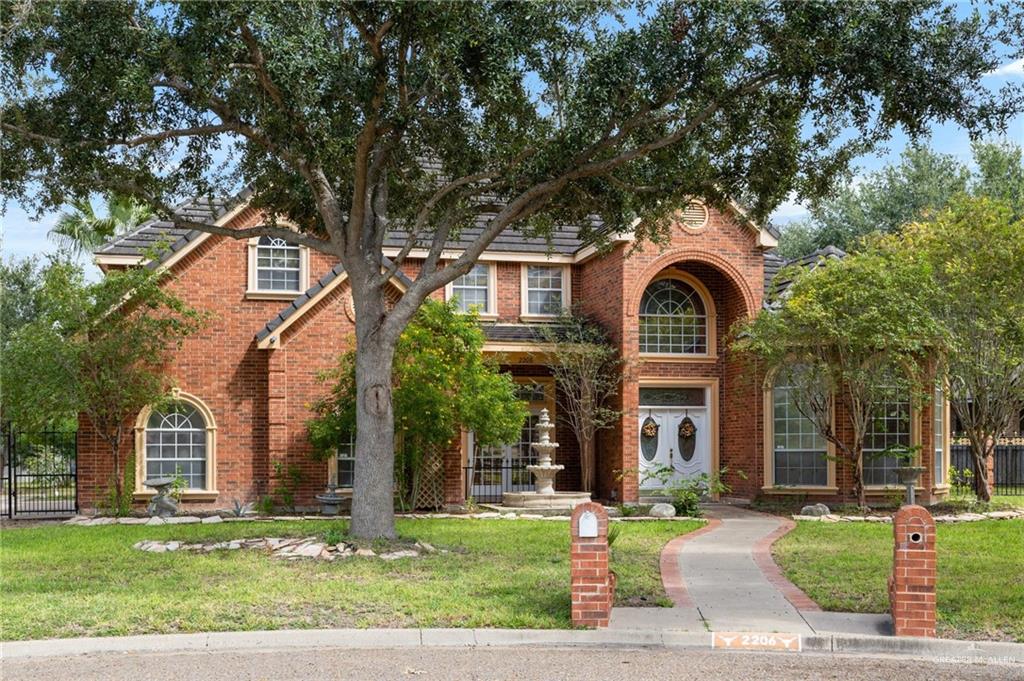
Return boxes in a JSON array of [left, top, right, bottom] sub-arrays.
[[0, 629, 1024, 665]]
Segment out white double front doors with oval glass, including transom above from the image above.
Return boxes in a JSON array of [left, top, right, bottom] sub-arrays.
[[637, 387, 713, 491]]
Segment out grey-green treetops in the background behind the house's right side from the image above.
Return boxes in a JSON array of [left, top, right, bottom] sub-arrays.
[[779, 142, 1024, 258]]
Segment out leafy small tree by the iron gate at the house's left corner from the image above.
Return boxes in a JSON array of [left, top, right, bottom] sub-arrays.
[[2, 263, 200, 510]]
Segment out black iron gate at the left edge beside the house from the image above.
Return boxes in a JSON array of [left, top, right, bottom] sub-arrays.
[[0, 426, 78, 518]]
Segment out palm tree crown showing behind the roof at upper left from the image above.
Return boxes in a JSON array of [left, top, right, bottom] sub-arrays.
[[49, 195, 153, 255]]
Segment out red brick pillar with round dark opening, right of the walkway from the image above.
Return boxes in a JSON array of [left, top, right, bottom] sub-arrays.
[[889, 506, 936, 638]]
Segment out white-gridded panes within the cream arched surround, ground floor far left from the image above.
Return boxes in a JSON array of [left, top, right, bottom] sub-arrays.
[[145, 401, 208, 490]]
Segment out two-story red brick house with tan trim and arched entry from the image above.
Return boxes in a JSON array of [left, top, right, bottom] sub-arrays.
[[79, 192, 949, 508]]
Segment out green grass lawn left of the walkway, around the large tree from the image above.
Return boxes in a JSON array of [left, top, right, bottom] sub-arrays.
[[0, 519, 700, 640]]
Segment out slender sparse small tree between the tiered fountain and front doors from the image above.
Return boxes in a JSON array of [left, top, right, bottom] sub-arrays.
[[543, 312, 624, 492]]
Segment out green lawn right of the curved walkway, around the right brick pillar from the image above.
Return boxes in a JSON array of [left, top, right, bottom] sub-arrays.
[[773, 520, 1024, 641]]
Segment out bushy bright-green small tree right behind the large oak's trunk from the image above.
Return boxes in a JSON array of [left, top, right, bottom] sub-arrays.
[[309, 300, 526, 508]]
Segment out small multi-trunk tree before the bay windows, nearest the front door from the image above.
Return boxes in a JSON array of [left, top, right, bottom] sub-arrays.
[[734, 249, 938, 507]]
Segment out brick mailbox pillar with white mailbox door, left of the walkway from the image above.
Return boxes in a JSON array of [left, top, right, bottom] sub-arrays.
[[569, 502, 615, 627]]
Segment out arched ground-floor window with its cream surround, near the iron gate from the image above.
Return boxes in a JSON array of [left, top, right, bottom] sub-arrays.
[[135, 390, 217, 494]]
